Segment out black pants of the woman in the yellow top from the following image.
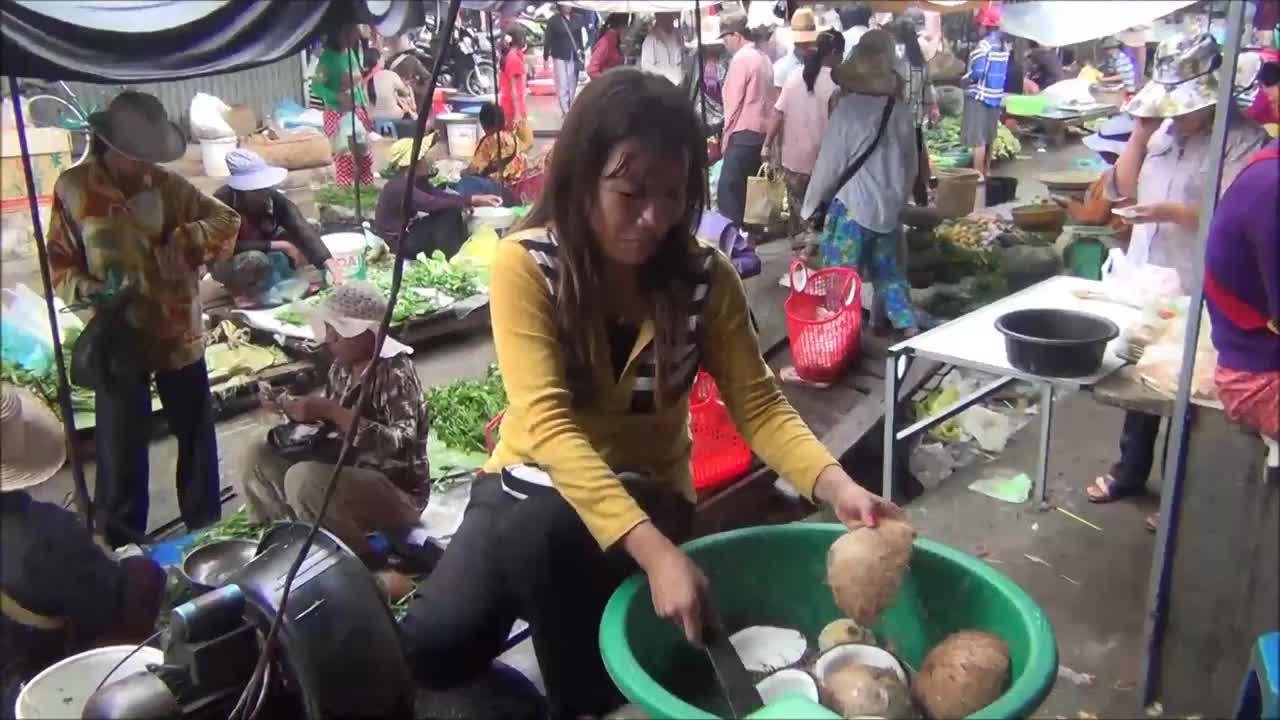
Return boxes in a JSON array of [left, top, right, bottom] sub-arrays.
[[401, 475, 692, 717]]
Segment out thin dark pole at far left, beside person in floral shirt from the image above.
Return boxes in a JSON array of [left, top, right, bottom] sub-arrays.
[[9, 77, 93, 534]]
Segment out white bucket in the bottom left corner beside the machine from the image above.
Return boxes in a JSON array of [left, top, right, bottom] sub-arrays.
[[13, 644, 164, 720]]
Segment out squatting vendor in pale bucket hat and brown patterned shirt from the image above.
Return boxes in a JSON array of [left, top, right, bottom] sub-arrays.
[[241, 281, 439, 570]]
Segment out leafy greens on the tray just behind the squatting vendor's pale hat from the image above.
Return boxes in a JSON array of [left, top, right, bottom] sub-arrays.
[[275, 250, 480, 325]]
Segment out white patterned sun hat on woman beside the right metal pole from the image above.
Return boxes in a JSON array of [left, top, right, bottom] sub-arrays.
[[1124, 33, 1222, 118]]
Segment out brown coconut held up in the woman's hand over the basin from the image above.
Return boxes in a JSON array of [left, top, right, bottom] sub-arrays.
[[827, 519, 915, 628]]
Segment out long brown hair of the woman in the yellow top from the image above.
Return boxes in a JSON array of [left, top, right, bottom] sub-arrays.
[[522, 68, 707, 407]]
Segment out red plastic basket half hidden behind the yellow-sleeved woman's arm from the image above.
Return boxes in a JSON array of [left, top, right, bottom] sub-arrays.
[[689, 370, 751, 491]]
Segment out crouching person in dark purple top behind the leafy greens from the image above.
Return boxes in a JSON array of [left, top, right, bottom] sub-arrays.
[[374, 137, 502, 256]]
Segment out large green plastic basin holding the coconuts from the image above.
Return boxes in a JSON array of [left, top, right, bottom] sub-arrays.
[[600, 523, 1057, 719]]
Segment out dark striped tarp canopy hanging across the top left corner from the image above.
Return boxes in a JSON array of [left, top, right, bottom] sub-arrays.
[[0, 0, 422, 83]]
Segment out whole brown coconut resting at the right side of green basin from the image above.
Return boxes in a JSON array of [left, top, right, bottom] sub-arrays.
[[911, 630, 1009, 719]]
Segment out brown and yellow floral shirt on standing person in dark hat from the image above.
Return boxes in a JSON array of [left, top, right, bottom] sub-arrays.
[[47, 158, 239, 370]]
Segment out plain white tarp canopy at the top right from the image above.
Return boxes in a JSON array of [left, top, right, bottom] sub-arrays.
[[1000, 0, 1194, 47]]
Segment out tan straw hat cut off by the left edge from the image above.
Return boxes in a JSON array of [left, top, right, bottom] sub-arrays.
[[0, 383, 67, 492]]
